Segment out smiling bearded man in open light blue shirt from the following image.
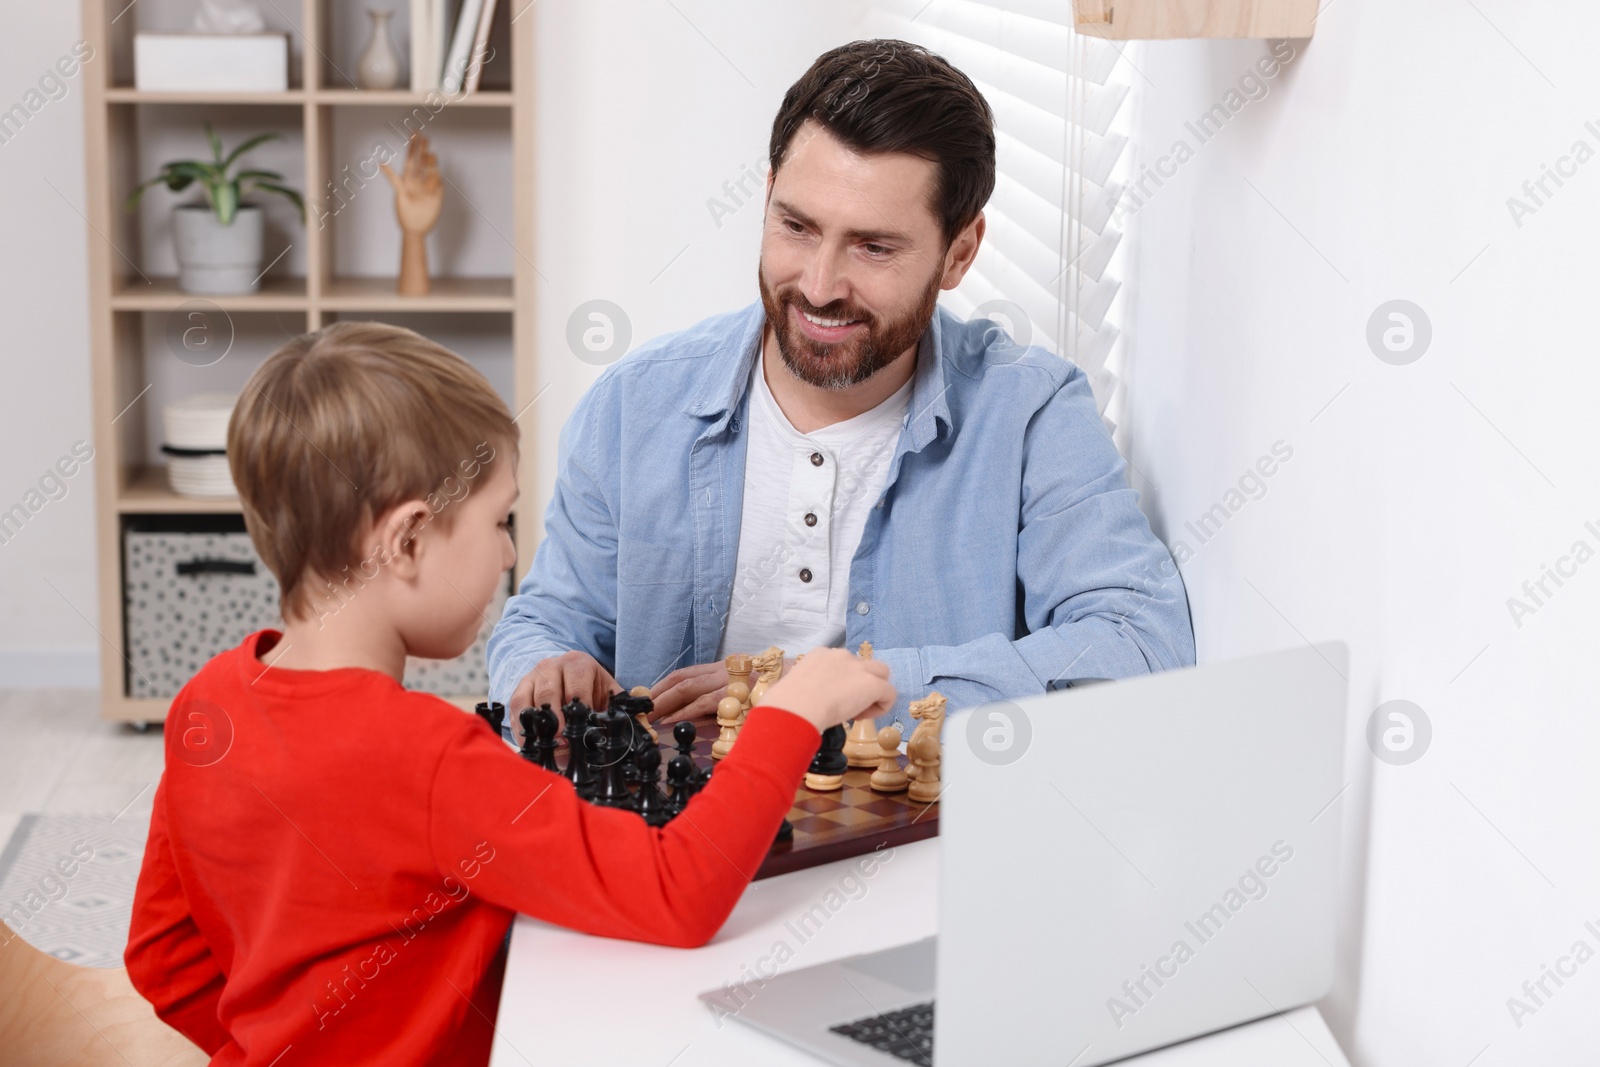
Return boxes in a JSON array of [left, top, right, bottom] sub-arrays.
[[488, 40, 1194, 742]]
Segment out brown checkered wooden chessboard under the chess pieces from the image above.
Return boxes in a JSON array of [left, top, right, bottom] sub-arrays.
[[684, 721, 939, 878]]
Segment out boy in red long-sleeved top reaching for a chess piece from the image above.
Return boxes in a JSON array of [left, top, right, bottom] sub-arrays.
[[125, 323, 894, 1067]]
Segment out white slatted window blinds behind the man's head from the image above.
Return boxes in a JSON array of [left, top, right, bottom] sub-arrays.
[[867, 0, 1130, 429]]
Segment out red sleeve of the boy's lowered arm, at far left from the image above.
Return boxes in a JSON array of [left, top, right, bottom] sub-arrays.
[[123, 781, 229, 1054]]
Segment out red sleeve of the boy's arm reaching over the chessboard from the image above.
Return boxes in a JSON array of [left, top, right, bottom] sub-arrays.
[[430, 707, 819, 947]]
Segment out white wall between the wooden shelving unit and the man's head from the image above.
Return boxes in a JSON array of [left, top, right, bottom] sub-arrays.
[[526, 0, 861, 524]]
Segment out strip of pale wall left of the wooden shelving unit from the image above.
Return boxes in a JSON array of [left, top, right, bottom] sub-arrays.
[[0, 3, 104, 685]]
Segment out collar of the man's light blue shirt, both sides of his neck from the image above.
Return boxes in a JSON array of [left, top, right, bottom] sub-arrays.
[[683, 301, 954, 451]]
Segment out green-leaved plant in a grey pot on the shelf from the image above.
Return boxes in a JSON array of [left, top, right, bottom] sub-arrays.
[[126, 123, 306, 293]]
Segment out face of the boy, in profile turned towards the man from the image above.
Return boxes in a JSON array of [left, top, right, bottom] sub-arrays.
[[397, 446, 517, 659]]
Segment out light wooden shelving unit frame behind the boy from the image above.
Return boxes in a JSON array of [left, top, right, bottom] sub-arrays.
[[82, 0, 538, 721]]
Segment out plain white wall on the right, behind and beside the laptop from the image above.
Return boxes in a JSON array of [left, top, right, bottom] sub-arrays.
[[1128, 0, 1600, 1067]]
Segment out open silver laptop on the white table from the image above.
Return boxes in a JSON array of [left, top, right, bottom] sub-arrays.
[[701, 643, 1349, 1067]]
